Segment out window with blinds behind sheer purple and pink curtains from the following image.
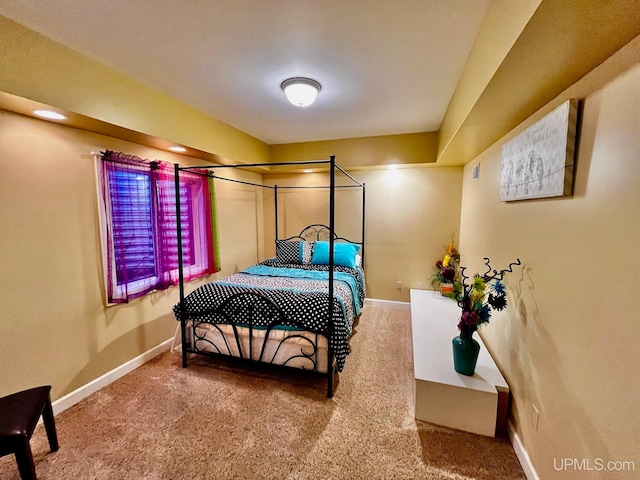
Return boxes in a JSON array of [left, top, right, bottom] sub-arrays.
[[98, 151, 217, 303]]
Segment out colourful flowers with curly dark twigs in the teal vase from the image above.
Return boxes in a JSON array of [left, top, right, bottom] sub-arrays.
[[455, 257, 520, 335]]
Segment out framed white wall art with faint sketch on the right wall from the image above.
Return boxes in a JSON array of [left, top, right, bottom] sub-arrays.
[[500, 98, 578, 202]]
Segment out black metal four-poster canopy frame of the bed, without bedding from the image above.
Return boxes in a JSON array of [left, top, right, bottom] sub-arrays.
[[174, 155, 365, 398]]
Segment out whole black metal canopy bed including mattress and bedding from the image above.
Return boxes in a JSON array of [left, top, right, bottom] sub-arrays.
[[174, 155, 365, 398]]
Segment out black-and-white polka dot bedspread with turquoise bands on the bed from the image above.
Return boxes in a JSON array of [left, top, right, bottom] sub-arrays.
[[173, 257, 365, 371]]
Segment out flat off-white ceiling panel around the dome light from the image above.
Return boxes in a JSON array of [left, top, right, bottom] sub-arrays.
[[0, 0, 491, 144]]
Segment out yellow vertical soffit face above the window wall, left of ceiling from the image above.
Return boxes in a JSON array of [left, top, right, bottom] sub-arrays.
[[0, 16, 269, 163]]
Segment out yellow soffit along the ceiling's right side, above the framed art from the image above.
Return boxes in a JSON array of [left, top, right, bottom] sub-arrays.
[[437, 0, 640, 165]]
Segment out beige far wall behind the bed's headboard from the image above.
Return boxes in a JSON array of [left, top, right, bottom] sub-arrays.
[[264, 166, 462, 302]]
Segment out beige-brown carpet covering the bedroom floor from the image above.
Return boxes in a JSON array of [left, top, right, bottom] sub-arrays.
[[0, 306, 525, 480]]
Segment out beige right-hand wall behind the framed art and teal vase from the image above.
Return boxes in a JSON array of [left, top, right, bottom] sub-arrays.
[[461, 39, 640, 479]]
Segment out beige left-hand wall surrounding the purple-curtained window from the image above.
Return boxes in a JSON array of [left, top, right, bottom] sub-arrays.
[[0, 110, 263, 399]]
